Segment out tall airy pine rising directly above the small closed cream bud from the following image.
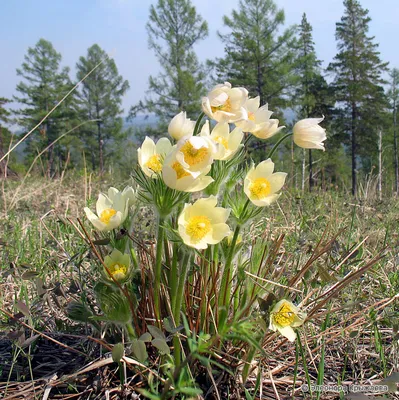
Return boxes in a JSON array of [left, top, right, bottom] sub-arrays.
[[130, 0, 208, 124]]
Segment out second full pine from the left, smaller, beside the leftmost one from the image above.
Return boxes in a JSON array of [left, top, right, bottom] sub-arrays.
[[76, 44, 129, 173]]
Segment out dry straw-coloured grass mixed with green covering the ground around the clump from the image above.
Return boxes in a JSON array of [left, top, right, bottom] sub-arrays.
[[0, 176, 399, 399]]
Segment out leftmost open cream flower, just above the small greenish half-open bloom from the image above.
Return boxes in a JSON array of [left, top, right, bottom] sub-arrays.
[[84, 187, 131, 232]]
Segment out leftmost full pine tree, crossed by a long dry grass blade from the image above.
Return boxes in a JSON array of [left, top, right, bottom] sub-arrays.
[[14, 39, 73, 176]]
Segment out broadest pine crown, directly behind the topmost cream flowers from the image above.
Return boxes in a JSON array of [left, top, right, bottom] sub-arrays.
[[210, 0, 296, 111]]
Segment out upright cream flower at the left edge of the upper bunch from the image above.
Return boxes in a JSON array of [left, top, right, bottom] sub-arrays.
[[137, 137, 172, 178]]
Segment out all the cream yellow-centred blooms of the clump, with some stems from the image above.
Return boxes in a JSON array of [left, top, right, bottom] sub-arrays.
[[85, 82, 326, 340]]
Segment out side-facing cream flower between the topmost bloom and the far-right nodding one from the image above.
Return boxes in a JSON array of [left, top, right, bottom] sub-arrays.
[[236, 96, 285, 139]]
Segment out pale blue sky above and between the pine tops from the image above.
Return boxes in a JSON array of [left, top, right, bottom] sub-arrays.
[[0, 0, 399, 112]]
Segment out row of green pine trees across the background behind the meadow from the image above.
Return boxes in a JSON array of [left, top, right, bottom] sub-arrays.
[[0, 0, 399, 198]]
